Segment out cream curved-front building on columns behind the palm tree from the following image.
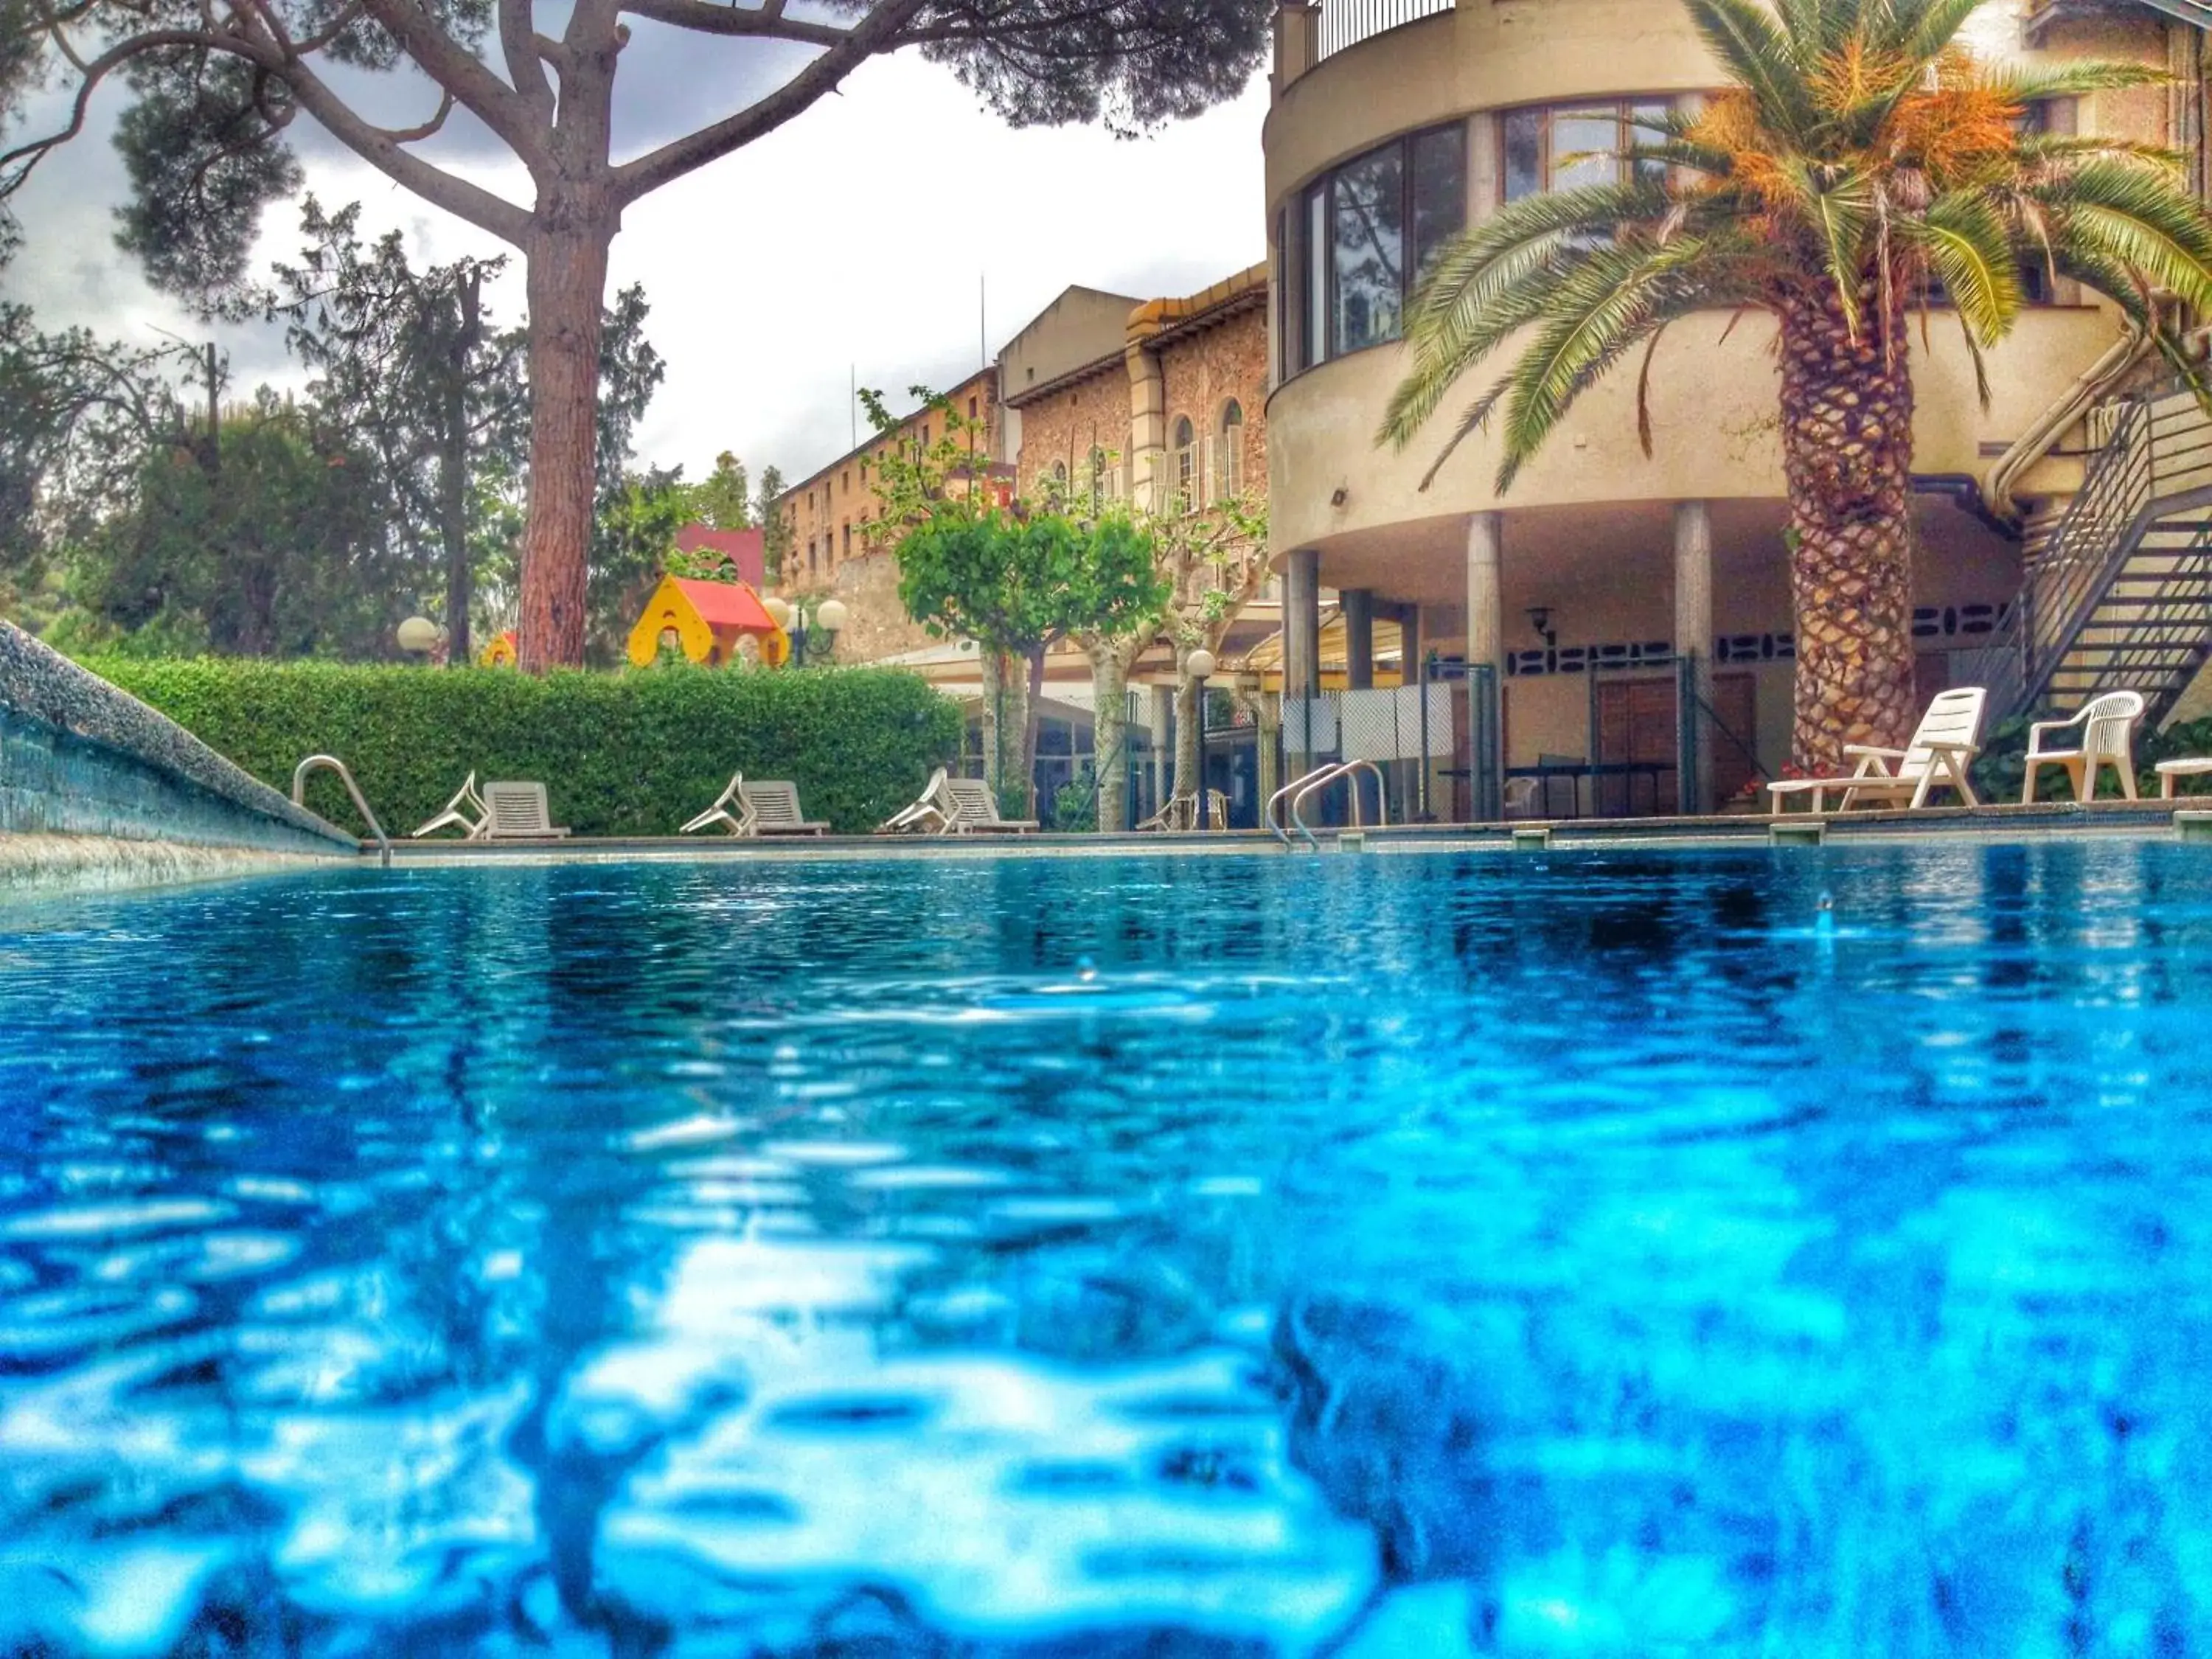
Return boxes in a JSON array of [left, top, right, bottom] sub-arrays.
[[1265, 0, 2201, 816]]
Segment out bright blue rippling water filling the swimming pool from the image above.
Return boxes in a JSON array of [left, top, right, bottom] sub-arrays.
[[0, 841, 2212, 1659]]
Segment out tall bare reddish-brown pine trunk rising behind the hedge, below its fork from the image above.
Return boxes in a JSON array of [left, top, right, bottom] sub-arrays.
[[515, 219, 615, 675]]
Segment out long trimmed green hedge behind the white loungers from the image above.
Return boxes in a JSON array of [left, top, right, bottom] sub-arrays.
[[86, 657, 960, 836]]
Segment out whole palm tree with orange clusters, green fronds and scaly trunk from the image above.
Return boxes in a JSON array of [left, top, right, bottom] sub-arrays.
[[1378, 0, 2212, 770]]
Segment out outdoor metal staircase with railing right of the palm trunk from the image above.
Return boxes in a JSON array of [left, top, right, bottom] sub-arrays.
[[1989, 392, 2212, 723]]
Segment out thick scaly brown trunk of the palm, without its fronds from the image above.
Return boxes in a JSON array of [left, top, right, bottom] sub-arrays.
[[1781, 281, 1916, 776]]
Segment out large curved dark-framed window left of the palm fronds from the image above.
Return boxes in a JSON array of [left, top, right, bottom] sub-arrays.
[[1283, 126, 1467, 369]]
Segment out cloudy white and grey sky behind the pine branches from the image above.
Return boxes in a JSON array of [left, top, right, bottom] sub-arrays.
[[0, 24, 1267, 480]]
